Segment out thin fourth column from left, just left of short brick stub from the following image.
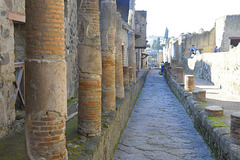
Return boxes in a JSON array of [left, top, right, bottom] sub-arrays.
[[115, 12, 124, 98]]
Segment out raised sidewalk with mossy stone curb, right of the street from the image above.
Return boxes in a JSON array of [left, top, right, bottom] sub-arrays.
[[165, 70, 240, 160]]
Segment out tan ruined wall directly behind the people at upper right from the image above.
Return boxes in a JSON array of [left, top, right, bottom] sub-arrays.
[[183, 28, 215, 56]]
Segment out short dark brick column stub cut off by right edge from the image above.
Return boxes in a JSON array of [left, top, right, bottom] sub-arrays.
[[231, 112, 240, 144]]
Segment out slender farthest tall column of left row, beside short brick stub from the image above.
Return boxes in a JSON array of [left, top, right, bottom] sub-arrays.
[[128, 30, 136, 84]]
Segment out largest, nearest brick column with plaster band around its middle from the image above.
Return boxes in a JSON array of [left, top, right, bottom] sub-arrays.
[[25, 0, 67, 159]]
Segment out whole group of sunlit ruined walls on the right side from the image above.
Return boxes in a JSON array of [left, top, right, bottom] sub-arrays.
[[163, 15, 240, 100]]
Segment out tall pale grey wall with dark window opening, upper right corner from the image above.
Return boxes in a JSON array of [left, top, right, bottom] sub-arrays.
[[216, 15, 240, 52]]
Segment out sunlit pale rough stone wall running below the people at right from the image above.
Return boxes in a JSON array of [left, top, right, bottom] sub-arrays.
[[179, 46, 240, 96]]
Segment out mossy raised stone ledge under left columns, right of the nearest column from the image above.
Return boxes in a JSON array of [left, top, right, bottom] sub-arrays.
[[66, 70, 148, 160]]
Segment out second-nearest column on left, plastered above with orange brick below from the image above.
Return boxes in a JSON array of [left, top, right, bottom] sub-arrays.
[[78, 0, 102, 136]]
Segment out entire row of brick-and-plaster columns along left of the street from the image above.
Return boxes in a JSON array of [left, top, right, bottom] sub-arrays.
[[25, 0, 136, 159]]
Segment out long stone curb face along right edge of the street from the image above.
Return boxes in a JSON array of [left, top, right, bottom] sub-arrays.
[[164, 70, 240, 160]]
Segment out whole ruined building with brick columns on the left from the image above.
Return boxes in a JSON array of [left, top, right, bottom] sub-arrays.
[[0, 0, 147, 159]]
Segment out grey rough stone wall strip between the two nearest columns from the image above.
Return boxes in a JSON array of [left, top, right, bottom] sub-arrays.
[[64, 0, 78, 99]]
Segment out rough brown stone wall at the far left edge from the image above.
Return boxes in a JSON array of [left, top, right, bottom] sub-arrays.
[[0, 0, 15, 137]]
